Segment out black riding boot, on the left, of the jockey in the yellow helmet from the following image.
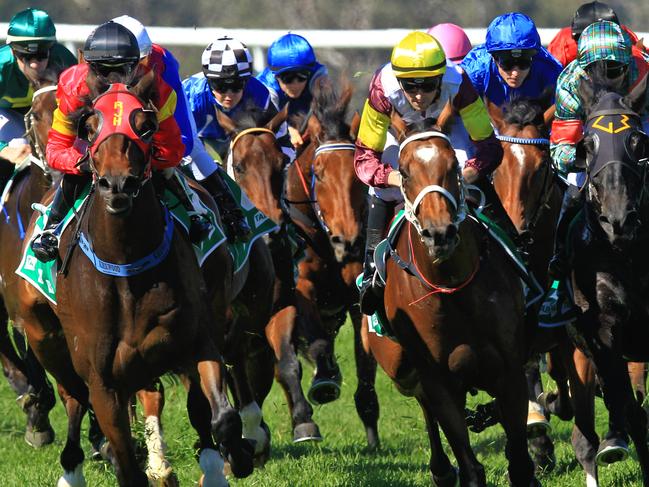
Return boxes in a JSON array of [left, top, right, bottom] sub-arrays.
[[359, 196, 392, 315]]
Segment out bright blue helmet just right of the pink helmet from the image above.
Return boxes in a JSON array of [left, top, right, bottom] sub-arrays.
[[485, 12, 541, 52]]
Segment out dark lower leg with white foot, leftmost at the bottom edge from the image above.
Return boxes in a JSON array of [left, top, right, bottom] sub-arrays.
[[56, 384, 86, 487]]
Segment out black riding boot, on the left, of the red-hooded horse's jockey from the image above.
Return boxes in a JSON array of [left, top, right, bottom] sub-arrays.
[[31, 174, 88, 262]]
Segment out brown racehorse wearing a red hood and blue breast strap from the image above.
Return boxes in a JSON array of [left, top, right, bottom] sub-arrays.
[[17, 73, 252, 486]]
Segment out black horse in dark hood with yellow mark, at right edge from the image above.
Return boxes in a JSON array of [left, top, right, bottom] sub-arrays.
[[571, 71, 649, 486]]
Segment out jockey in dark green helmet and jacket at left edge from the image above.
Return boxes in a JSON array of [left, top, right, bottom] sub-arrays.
[[0, 8, 77, 183]]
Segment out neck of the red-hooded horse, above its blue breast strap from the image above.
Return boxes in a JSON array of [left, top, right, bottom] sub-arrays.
[[82, 181, 165, 264]]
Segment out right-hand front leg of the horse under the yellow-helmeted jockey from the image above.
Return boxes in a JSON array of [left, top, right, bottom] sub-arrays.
[[496, 370, 538, 487]]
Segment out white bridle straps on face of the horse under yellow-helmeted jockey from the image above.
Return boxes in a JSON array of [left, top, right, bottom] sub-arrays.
[[399, 131, 467, 235]]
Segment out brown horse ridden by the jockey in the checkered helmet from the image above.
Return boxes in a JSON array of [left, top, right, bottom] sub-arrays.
[[217, 102, 322, 442]]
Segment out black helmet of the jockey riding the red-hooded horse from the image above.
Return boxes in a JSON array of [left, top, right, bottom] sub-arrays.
[[83, 21, 140, 64]]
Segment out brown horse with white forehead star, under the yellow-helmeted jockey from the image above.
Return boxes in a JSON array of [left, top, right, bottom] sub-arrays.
[[366, 119, 538, 486]]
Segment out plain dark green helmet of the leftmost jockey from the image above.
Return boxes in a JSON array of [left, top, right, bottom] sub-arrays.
[[7, 8, 56, 54]]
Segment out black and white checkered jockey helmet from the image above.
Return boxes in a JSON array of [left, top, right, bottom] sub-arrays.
[[201, 36, 252, 79]]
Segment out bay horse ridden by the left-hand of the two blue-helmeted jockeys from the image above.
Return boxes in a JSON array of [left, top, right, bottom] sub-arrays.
[[285, 80, 379, 448]]
